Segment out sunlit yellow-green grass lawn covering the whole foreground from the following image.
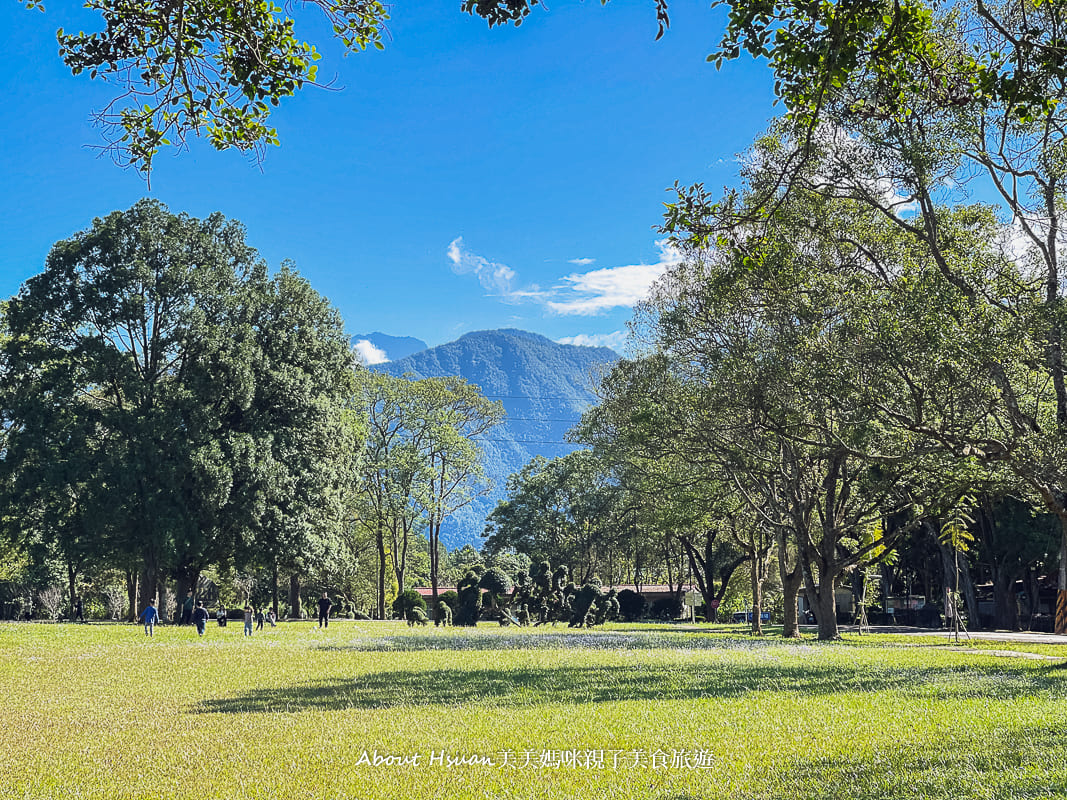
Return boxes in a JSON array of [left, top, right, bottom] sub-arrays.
[[0, 622, 1067, 800]]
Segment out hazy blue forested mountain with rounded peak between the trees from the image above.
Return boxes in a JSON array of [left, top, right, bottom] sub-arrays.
[[375, 330, 619, 549]]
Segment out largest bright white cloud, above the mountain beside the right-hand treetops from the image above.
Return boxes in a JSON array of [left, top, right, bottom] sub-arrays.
[[545, 239, 682, 316]]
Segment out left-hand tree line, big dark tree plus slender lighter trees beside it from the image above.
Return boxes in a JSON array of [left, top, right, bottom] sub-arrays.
[[0, 201, 503, 617]]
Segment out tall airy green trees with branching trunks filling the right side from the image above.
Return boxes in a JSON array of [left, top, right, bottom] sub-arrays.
[[486, 0, 1067, 638]]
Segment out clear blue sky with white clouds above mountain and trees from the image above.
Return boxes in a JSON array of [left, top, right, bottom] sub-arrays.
[[0, 0, 777, 356]]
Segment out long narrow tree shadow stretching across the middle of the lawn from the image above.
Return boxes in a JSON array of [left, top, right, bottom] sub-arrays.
[[195, 663, 1067, 714]]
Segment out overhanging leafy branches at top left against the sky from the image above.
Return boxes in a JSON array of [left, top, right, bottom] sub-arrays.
[[45, 0, 388, 175]]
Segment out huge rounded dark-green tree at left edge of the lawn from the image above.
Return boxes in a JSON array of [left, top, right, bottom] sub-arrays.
[[2, 201, 349, 618]]
